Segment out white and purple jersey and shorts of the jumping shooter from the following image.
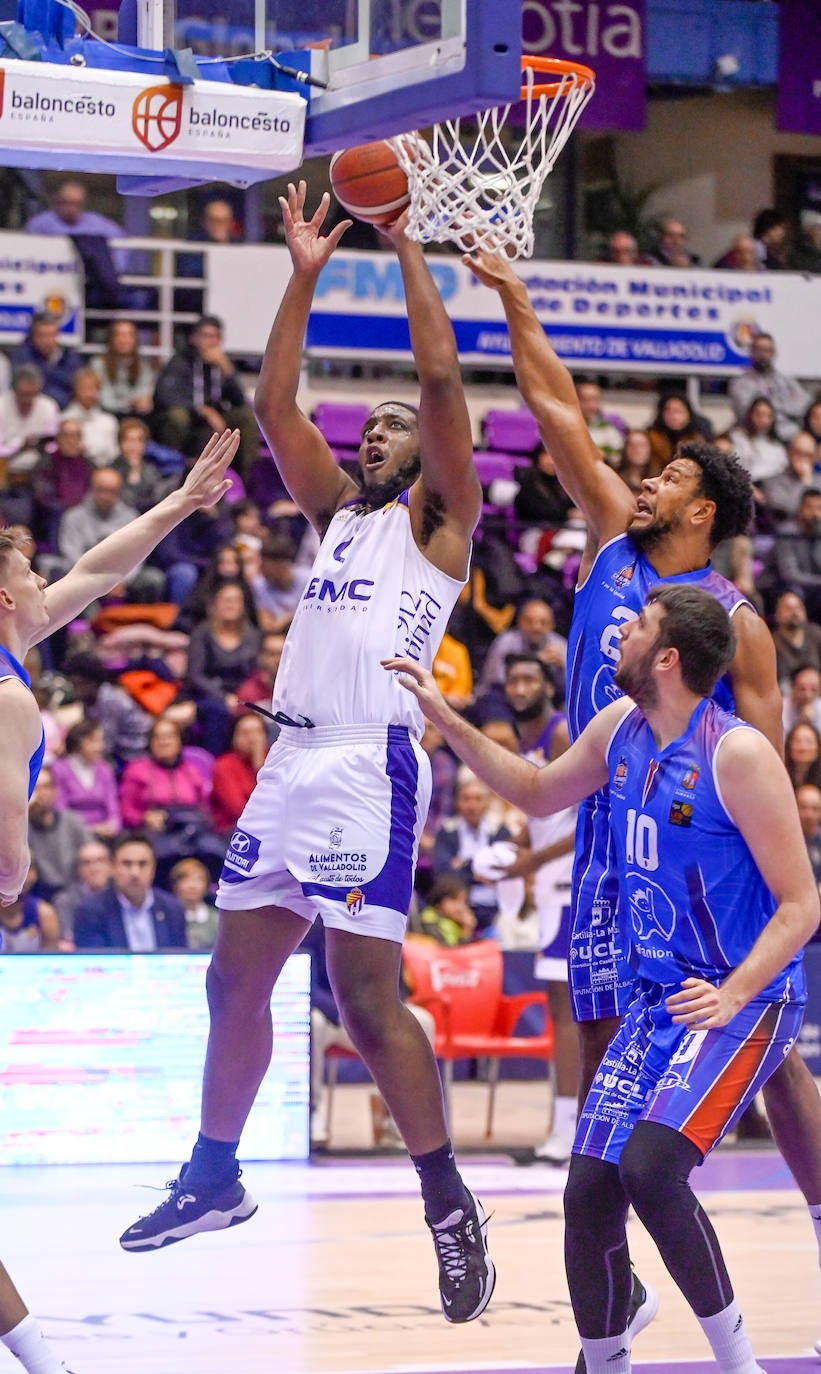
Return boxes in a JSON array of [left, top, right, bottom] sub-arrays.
[[217, 492, 464, 941]]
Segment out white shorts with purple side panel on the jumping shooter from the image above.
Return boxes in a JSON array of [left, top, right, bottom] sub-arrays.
[[217, 725, 431, 944]]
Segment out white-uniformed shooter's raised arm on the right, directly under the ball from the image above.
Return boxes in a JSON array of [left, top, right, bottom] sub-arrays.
[[383, 216, 482, 577]]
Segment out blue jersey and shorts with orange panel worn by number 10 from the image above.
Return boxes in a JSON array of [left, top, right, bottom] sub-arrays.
[[574, 699, 806, 1164]]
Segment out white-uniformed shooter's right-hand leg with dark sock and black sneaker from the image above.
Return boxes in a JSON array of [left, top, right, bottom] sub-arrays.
[[325, 929, 496, 1322]]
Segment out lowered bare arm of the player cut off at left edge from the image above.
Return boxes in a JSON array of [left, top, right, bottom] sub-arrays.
[[0, 677, 43, 907]]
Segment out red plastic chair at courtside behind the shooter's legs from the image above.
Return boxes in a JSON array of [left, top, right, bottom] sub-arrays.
[[402, 937, 553, 1140]]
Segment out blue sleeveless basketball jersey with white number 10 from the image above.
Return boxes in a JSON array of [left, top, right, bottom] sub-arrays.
[[607, 699, 806, 1002]]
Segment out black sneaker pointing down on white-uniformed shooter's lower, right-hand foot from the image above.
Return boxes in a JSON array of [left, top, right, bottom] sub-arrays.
[[427, 1193, 496, 1322]]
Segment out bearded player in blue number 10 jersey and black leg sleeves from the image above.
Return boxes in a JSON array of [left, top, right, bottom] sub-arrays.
[[384, 584, 821, 1374]]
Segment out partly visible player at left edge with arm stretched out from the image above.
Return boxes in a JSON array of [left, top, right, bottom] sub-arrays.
[[0, 431, 239, 1374]]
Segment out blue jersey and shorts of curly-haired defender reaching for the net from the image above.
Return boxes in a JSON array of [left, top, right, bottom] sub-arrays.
[[567, 534, 750, 1021]]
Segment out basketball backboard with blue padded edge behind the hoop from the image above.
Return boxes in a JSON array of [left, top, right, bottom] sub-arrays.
[[137, 0, 522, 157]]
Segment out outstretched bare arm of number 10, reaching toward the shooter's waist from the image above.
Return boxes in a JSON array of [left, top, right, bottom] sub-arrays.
[[382, 658, 620, 816]]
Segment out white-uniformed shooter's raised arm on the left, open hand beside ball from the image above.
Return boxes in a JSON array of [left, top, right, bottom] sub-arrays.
[[254, 181, 357, 534]]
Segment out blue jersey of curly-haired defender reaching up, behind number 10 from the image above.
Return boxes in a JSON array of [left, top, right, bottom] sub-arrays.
[[567, 534, 750, 741]]
